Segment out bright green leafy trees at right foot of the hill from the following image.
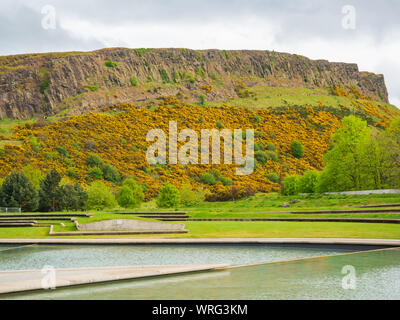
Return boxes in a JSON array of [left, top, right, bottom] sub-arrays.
[[281, 116, 400, 195]]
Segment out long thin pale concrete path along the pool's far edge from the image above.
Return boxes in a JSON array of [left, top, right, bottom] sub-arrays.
[[0, 238, 400, 247]]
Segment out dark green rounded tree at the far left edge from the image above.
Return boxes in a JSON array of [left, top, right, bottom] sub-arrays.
[[0, 172, 39, 212]]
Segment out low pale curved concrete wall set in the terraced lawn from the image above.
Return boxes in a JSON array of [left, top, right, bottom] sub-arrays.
[[77, 219, 185, 231]]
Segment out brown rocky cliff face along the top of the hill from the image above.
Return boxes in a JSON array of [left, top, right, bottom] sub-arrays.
[[0, 48, 388, 119]]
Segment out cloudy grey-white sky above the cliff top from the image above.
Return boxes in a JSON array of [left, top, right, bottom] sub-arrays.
[[0, 0, 400, 107]]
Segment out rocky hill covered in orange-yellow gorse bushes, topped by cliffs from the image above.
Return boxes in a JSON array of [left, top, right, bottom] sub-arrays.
[[0, 48, 400, 200]]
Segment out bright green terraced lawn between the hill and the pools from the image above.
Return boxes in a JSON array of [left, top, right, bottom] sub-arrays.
[[0, 194, 400, 239]]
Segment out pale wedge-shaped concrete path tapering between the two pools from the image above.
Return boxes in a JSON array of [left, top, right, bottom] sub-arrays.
[[0, 264, 228, 294]]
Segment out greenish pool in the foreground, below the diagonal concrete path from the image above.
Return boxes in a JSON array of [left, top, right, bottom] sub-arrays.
[[3, 249, 400, 300]]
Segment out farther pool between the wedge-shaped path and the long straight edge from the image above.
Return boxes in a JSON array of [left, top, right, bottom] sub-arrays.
[[0, 245, 354, 270]]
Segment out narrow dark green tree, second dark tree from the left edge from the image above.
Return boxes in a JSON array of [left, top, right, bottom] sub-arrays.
[[39, 169, 61, 212]]
